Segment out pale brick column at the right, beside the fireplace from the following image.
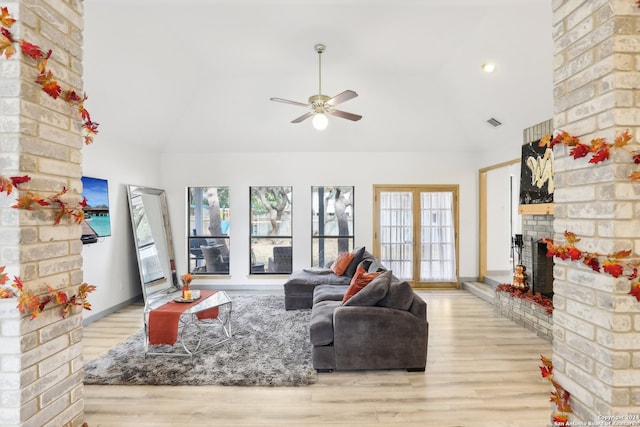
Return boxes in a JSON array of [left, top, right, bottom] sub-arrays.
[[553, 0, 640, 425]]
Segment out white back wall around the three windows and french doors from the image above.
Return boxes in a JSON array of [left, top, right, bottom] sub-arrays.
[[162, 152, 478, 286]]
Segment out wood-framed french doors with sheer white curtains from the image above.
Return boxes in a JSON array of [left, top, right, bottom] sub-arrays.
[[373, 185, 458, 288]]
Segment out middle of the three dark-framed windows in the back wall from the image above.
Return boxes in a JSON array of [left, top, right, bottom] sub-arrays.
[[249, 187, 293, 274]]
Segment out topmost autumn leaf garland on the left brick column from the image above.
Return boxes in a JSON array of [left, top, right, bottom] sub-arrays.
[[0, 7, 99, 144]]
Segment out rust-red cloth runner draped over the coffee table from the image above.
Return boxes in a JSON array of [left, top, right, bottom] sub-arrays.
[[149, 291, 218, 345]]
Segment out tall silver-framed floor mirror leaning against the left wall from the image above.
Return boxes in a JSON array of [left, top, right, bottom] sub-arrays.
[[127, 185, 178, 303]]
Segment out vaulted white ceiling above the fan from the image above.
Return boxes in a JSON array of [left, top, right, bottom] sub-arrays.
[[83, 0, 553, 153]]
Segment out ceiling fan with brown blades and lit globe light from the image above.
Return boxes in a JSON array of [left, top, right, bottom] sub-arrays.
[[271, 44, 362, 130]]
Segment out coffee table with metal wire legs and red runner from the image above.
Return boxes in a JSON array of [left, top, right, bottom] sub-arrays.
[[144, 291, 232, 357]]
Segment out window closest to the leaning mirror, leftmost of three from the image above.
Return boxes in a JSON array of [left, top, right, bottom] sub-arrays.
[[187, 187, 231, 274]]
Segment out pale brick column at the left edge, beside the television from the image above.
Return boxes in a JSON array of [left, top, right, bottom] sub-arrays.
[[0, 0, 83, 426]]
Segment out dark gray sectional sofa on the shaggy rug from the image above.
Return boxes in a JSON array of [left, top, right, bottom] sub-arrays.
[[284, 248, 429, 371]]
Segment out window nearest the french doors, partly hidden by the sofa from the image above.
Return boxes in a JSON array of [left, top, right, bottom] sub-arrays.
[[311, 187, 354, 267]]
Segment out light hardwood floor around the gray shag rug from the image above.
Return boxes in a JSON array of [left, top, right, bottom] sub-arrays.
[[83, 290, 552, 427]]
